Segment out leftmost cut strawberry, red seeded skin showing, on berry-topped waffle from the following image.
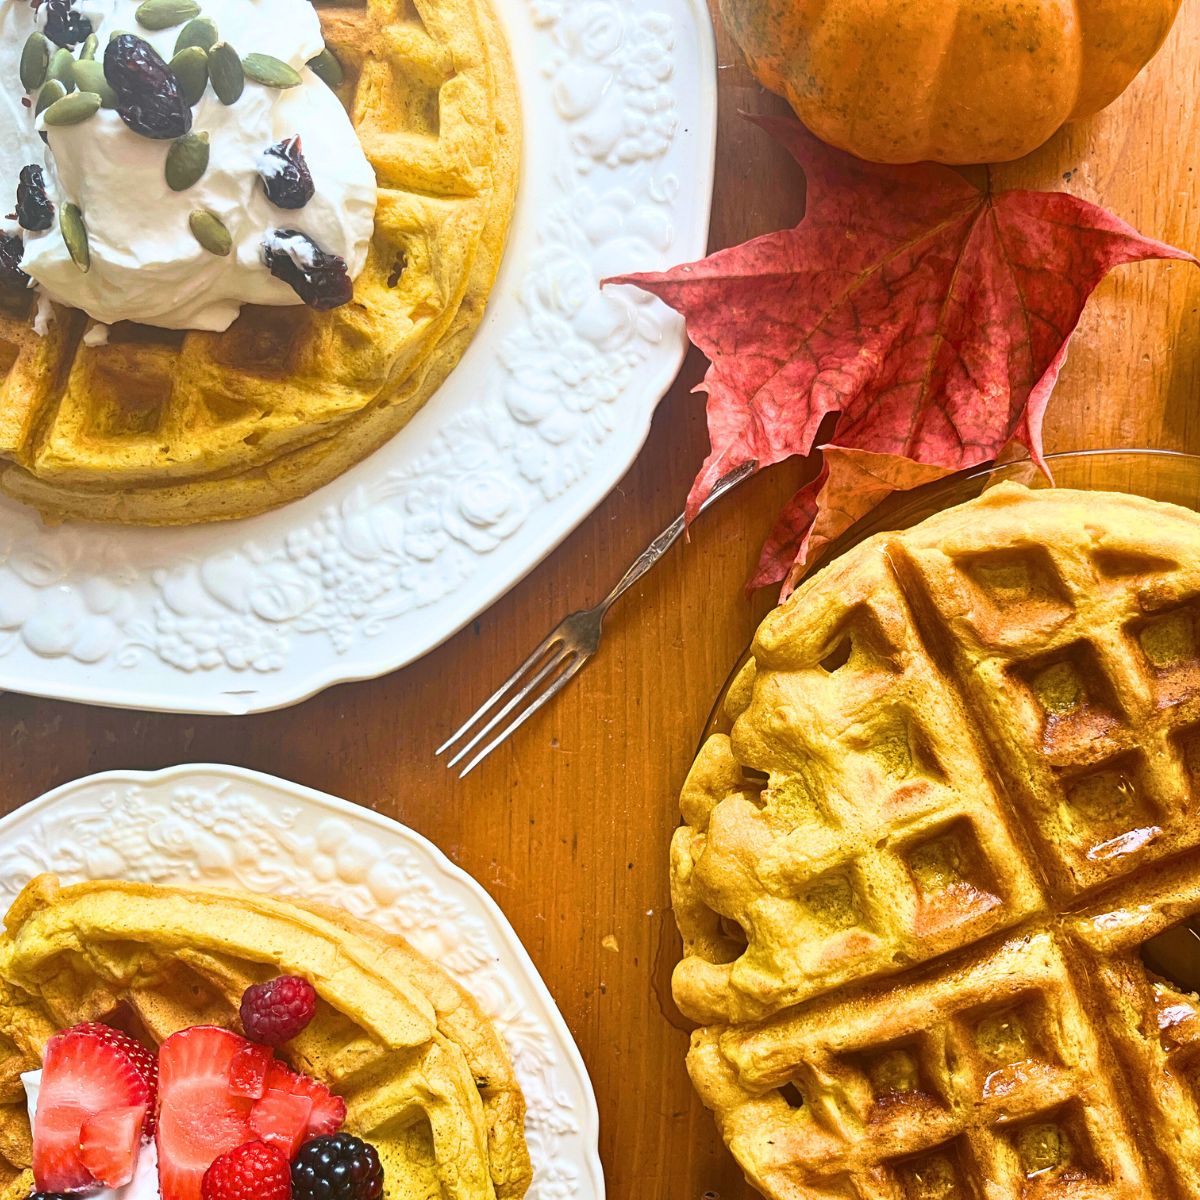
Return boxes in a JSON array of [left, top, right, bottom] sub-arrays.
[[34, 1024, 155, 1192]]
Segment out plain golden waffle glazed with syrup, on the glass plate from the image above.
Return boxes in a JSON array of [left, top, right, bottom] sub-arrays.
[[672, 485, 1200, 1200]]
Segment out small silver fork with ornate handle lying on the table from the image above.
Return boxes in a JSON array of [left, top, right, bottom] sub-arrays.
[[437, 462, 755, 779]]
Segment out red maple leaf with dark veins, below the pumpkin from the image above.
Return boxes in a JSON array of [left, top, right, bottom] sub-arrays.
[[606, 118, 1195, 588]]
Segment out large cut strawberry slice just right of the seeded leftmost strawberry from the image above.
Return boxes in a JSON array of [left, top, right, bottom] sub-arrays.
[[156, 1025, 253, 1200]]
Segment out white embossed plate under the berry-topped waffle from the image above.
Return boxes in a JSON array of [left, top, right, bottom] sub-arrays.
[[0, 766, 605, 1200]]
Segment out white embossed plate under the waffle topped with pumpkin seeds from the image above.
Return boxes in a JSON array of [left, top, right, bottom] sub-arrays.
[[0, 0, 716, 713]]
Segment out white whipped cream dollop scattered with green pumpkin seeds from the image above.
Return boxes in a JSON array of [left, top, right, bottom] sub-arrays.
[[0, 0, 377, 330]]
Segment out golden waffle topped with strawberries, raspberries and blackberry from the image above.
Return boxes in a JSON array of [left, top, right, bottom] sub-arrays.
[[0, 876, 530, 1200]]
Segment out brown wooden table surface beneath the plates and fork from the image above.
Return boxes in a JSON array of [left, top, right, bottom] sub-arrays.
[[0, 0, 1200, 1200]]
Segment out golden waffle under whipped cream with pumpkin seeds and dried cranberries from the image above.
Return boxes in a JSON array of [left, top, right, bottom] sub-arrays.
[[0, 0, 521, 524]]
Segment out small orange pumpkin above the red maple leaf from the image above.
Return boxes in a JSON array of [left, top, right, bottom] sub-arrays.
[[721, 0, 1181, 163]]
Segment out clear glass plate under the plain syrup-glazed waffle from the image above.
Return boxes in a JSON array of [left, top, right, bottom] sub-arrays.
[[704, 450, 1200, 739]]
